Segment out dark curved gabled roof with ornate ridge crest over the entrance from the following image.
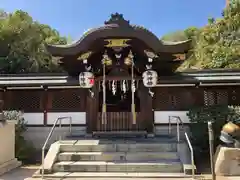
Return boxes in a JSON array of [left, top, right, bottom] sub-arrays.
[[46, 13, 191, 56]]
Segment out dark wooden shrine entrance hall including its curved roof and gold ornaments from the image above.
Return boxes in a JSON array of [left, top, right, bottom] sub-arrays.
[[44, 13, 191, 136]]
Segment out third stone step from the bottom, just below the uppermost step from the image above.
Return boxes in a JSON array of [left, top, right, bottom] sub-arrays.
[[58, 152, 179, 161]]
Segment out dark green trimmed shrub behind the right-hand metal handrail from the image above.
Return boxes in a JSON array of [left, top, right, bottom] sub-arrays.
[[187, 105, 240, 158]]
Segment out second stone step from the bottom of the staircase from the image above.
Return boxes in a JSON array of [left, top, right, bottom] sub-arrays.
[[53, 161, 183, 173]]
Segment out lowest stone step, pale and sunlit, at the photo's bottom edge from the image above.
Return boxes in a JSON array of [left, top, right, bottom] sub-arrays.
[[33, 172, 190, 180]]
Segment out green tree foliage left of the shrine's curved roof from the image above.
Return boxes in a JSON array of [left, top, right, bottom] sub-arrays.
[[0, 11, 67, 73]]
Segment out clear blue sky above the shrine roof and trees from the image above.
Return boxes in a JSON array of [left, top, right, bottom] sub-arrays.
[[0, 0, 225, 40]]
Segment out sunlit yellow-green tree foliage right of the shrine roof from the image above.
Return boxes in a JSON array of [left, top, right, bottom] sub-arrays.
[[179, 0, 240, 70]]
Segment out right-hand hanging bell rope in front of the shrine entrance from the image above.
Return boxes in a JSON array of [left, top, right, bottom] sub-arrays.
[[128, 51, 136, 124]]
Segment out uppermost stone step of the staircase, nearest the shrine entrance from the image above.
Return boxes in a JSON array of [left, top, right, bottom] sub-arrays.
[[60, 143, 177, 152]]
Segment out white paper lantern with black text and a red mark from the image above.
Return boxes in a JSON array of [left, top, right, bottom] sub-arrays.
[[79, 72, 94, 88]]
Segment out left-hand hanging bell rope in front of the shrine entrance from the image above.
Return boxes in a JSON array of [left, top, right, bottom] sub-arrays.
[[102, 52, 108, 124]]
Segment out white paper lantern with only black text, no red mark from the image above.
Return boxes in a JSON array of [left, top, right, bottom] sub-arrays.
[[142, 70, 158, 88]]
